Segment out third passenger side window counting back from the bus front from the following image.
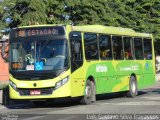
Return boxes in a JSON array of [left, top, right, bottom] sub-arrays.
[[112, 36, 123, 60]]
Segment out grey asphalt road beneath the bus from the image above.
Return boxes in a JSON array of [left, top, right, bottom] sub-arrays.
[[0, 81, 160, 120]]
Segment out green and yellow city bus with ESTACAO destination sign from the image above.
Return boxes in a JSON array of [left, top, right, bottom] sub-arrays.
[[5, 25, 155, 104]]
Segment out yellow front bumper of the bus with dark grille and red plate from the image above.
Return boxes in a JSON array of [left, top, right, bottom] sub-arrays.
[[9, 79, 71, 100]]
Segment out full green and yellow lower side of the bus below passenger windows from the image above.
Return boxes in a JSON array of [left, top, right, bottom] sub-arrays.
[[80, 60, 154, 94]]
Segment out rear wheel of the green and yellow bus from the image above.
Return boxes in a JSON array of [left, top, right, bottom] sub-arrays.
[[127, 76, 138, 97]]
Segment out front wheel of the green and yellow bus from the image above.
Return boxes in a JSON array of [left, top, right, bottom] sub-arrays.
[[80, 80, 96, 105]]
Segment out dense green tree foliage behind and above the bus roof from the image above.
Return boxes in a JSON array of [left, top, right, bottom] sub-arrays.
[[0, 0, 160, 52]]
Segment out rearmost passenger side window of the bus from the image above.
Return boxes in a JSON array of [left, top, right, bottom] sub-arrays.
[[143, 38, 152, 60]]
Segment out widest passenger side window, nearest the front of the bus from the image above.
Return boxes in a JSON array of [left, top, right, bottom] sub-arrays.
[[84, 33, 99, 60]]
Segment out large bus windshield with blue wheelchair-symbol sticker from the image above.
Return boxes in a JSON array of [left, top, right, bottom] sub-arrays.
[[10, 39, 69, 71]]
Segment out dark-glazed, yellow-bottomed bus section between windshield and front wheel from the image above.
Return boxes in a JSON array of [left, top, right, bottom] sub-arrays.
[[69, 31, 85, 96]]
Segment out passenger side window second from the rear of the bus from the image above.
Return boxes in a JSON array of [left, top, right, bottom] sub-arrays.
[[134, 38, 144, 60]]
